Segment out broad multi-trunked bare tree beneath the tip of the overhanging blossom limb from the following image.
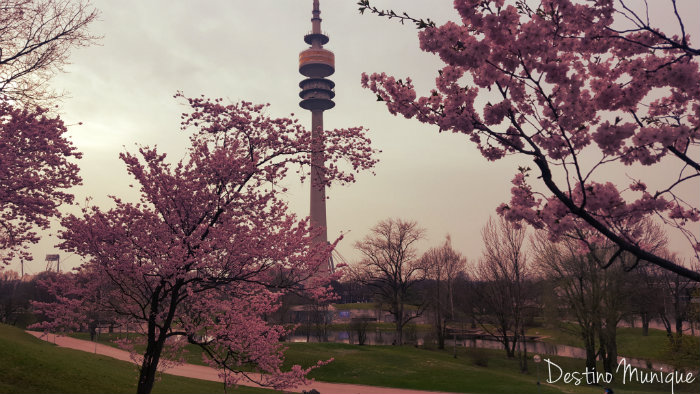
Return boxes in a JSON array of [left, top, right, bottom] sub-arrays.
[[532, 231, 641, 373]]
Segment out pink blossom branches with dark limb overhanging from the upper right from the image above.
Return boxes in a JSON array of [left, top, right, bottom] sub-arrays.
[[358, 0, 700, 281]]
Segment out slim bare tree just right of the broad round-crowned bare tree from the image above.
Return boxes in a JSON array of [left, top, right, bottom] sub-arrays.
[[421, 235, 467, 349]]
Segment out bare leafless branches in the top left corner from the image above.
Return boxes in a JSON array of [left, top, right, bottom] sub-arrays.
[[0, 0, 98, 104]]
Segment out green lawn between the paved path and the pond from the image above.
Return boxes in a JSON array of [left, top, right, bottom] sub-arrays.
[[65, 334, 700, 393]]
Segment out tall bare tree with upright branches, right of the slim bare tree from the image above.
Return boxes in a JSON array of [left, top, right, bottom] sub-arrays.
[[473, 218, 530, 372]]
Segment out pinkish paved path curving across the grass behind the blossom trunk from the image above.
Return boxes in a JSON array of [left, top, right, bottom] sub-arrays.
[[27, 331, 454, 394]]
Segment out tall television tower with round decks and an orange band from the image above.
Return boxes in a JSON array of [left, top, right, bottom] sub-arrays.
[[299, 0, 335, 272]]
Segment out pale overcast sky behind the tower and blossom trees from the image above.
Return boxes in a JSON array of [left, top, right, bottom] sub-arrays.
[[8, 0, 700, 273]]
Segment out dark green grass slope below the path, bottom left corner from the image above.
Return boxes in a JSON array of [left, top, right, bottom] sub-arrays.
[[0, 324, 277, 393]]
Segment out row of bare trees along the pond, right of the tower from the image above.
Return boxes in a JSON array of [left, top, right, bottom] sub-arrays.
[[335, 219, 699, 372]]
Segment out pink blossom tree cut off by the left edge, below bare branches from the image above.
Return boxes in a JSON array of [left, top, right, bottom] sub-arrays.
[[0, 101, 81, 266]]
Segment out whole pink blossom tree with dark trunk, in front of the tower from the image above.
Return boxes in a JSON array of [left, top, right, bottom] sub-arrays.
[[43, 94, 375, 393]]
